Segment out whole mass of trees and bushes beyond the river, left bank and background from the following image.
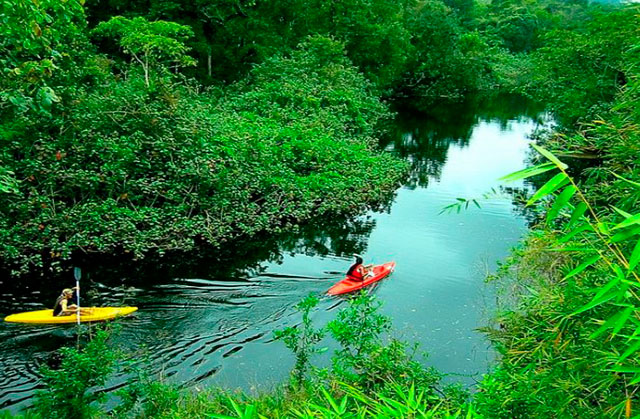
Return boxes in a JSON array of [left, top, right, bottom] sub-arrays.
[[7, 0, 636, 273]]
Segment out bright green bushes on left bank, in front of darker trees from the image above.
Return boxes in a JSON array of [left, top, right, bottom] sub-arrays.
[[0, 0, 403, 272]]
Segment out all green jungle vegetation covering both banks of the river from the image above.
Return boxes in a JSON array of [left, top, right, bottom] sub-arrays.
[[0, 0, 640, 418]]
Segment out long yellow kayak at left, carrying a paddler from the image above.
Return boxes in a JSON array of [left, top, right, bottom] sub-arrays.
[[4, 307, 138, 324]]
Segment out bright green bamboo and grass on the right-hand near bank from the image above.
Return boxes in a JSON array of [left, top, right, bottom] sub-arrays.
[[476, 146, 640, 417]]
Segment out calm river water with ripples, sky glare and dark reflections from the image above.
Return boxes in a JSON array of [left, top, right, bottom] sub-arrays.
[[0, 98, 541, 412]]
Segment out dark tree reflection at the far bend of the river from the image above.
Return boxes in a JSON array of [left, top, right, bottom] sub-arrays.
[[381, 95, 542, 188]]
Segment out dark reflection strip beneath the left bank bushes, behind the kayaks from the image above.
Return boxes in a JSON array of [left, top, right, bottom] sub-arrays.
[[0, 212, 376, 304]]
